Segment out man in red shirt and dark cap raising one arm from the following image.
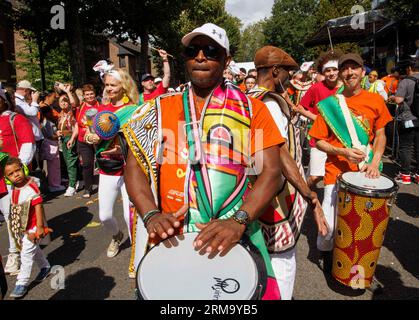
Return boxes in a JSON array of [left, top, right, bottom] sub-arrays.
[[139, 50, 170, 105]]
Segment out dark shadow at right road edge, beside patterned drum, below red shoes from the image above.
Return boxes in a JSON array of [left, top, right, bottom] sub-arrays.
[[383, 219, 419, 279]]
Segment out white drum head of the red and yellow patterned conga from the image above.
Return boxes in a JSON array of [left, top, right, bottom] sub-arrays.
[[341, 172, 397, 192]]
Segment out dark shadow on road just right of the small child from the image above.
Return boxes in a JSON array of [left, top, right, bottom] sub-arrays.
[[47, 207, 93, 267]]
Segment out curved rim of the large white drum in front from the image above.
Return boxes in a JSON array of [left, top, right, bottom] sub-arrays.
[[135, 232, 267, 300]]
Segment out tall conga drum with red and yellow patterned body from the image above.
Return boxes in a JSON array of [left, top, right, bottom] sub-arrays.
[[332, 172, 398, 289]]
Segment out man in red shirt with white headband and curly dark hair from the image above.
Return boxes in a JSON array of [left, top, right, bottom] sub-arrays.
[[294, 51, 341, 187]]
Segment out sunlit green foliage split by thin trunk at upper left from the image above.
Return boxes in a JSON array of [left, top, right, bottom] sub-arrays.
[[15, 32, 72, 90]]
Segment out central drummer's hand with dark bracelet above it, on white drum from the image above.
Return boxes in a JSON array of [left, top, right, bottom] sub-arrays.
[[145, 204, 188, 239]]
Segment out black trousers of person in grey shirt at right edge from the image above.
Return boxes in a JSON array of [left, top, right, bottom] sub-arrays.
[[399, 128, 419, 174]]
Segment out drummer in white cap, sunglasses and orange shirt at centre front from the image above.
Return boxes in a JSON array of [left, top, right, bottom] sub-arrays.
[[123, 23, 316, 299]]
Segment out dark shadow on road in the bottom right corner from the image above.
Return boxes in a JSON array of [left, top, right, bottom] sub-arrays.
[[372, 265, 419, 300]]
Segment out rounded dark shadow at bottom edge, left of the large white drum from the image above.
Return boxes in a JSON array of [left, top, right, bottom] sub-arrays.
[[50, 268, 116, 300]]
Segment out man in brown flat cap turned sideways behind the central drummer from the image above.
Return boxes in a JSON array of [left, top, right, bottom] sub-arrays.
[[249, 46, 327, 300]]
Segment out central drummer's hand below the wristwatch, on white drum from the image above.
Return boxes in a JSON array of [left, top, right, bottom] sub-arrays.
[[194, 218, 246, 253]]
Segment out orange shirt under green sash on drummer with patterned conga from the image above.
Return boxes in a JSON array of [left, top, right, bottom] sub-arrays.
[[309, 90, 392, 185]]
